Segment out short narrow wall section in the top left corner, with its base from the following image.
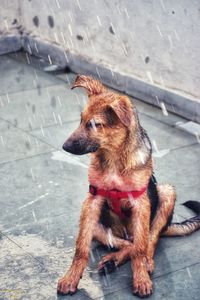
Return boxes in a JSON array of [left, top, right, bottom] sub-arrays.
[[0, 0, 21, 54]]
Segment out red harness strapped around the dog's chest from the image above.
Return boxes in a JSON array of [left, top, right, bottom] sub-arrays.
[[89, 185, 147, 219]]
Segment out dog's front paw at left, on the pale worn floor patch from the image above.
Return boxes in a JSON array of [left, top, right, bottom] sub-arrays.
[[57, 274, 79, 295]]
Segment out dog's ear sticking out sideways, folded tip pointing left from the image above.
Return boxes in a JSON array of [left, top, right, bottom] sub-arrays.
[[72, 75, 106, 96]]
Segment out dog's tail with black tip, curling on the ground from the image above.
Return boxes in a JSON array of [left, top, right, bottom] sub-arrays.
[[162, 201, 200, 236]]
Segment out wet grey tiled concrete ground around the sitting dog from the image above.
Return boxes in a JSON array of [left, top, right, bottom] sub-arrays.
[[0, 53, 200, 300]]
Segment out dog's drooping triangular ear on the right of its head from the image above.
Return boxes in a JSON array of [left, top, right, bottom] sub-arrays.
[[110, 96, 133, 127]]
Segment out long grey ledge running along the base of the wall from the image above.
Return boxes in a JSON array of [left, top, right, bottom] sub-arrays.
[[0, 36, 200, 123]]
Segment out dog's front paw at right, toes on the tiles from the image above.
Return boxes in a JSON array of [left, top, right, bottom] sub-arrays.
[[133, 278, 153, 298]]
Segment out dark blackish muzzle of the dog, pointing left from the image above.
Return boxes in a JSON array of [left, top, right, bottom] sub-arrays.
[[62, 139, 100, 155]]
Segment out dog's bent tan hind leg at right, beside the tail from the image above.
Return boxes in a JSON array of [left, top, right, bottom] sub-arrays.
[[147, 184, 176, 272]]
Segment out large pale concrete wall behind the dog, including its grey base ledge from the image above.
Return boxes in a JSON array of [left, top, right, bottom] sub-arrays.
[[0, 0, 200, 122]]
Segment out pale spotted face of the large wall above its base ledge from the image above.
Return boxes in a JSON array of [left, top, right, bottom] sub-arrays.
[[22, 0, 200, 97]]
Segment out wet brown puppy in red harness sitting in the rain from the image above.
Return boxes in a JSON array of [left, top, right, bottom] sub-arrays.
[[58, 75, 200, 297]]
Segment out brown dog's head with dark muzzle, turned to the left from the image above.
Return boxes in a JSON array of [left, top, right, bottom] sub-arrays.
[[63, 75, 135, 155]]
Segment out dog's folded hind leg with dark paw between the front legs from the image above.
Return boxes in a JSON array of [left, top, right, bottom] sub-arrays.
[[94, 224, 132, 273]]
